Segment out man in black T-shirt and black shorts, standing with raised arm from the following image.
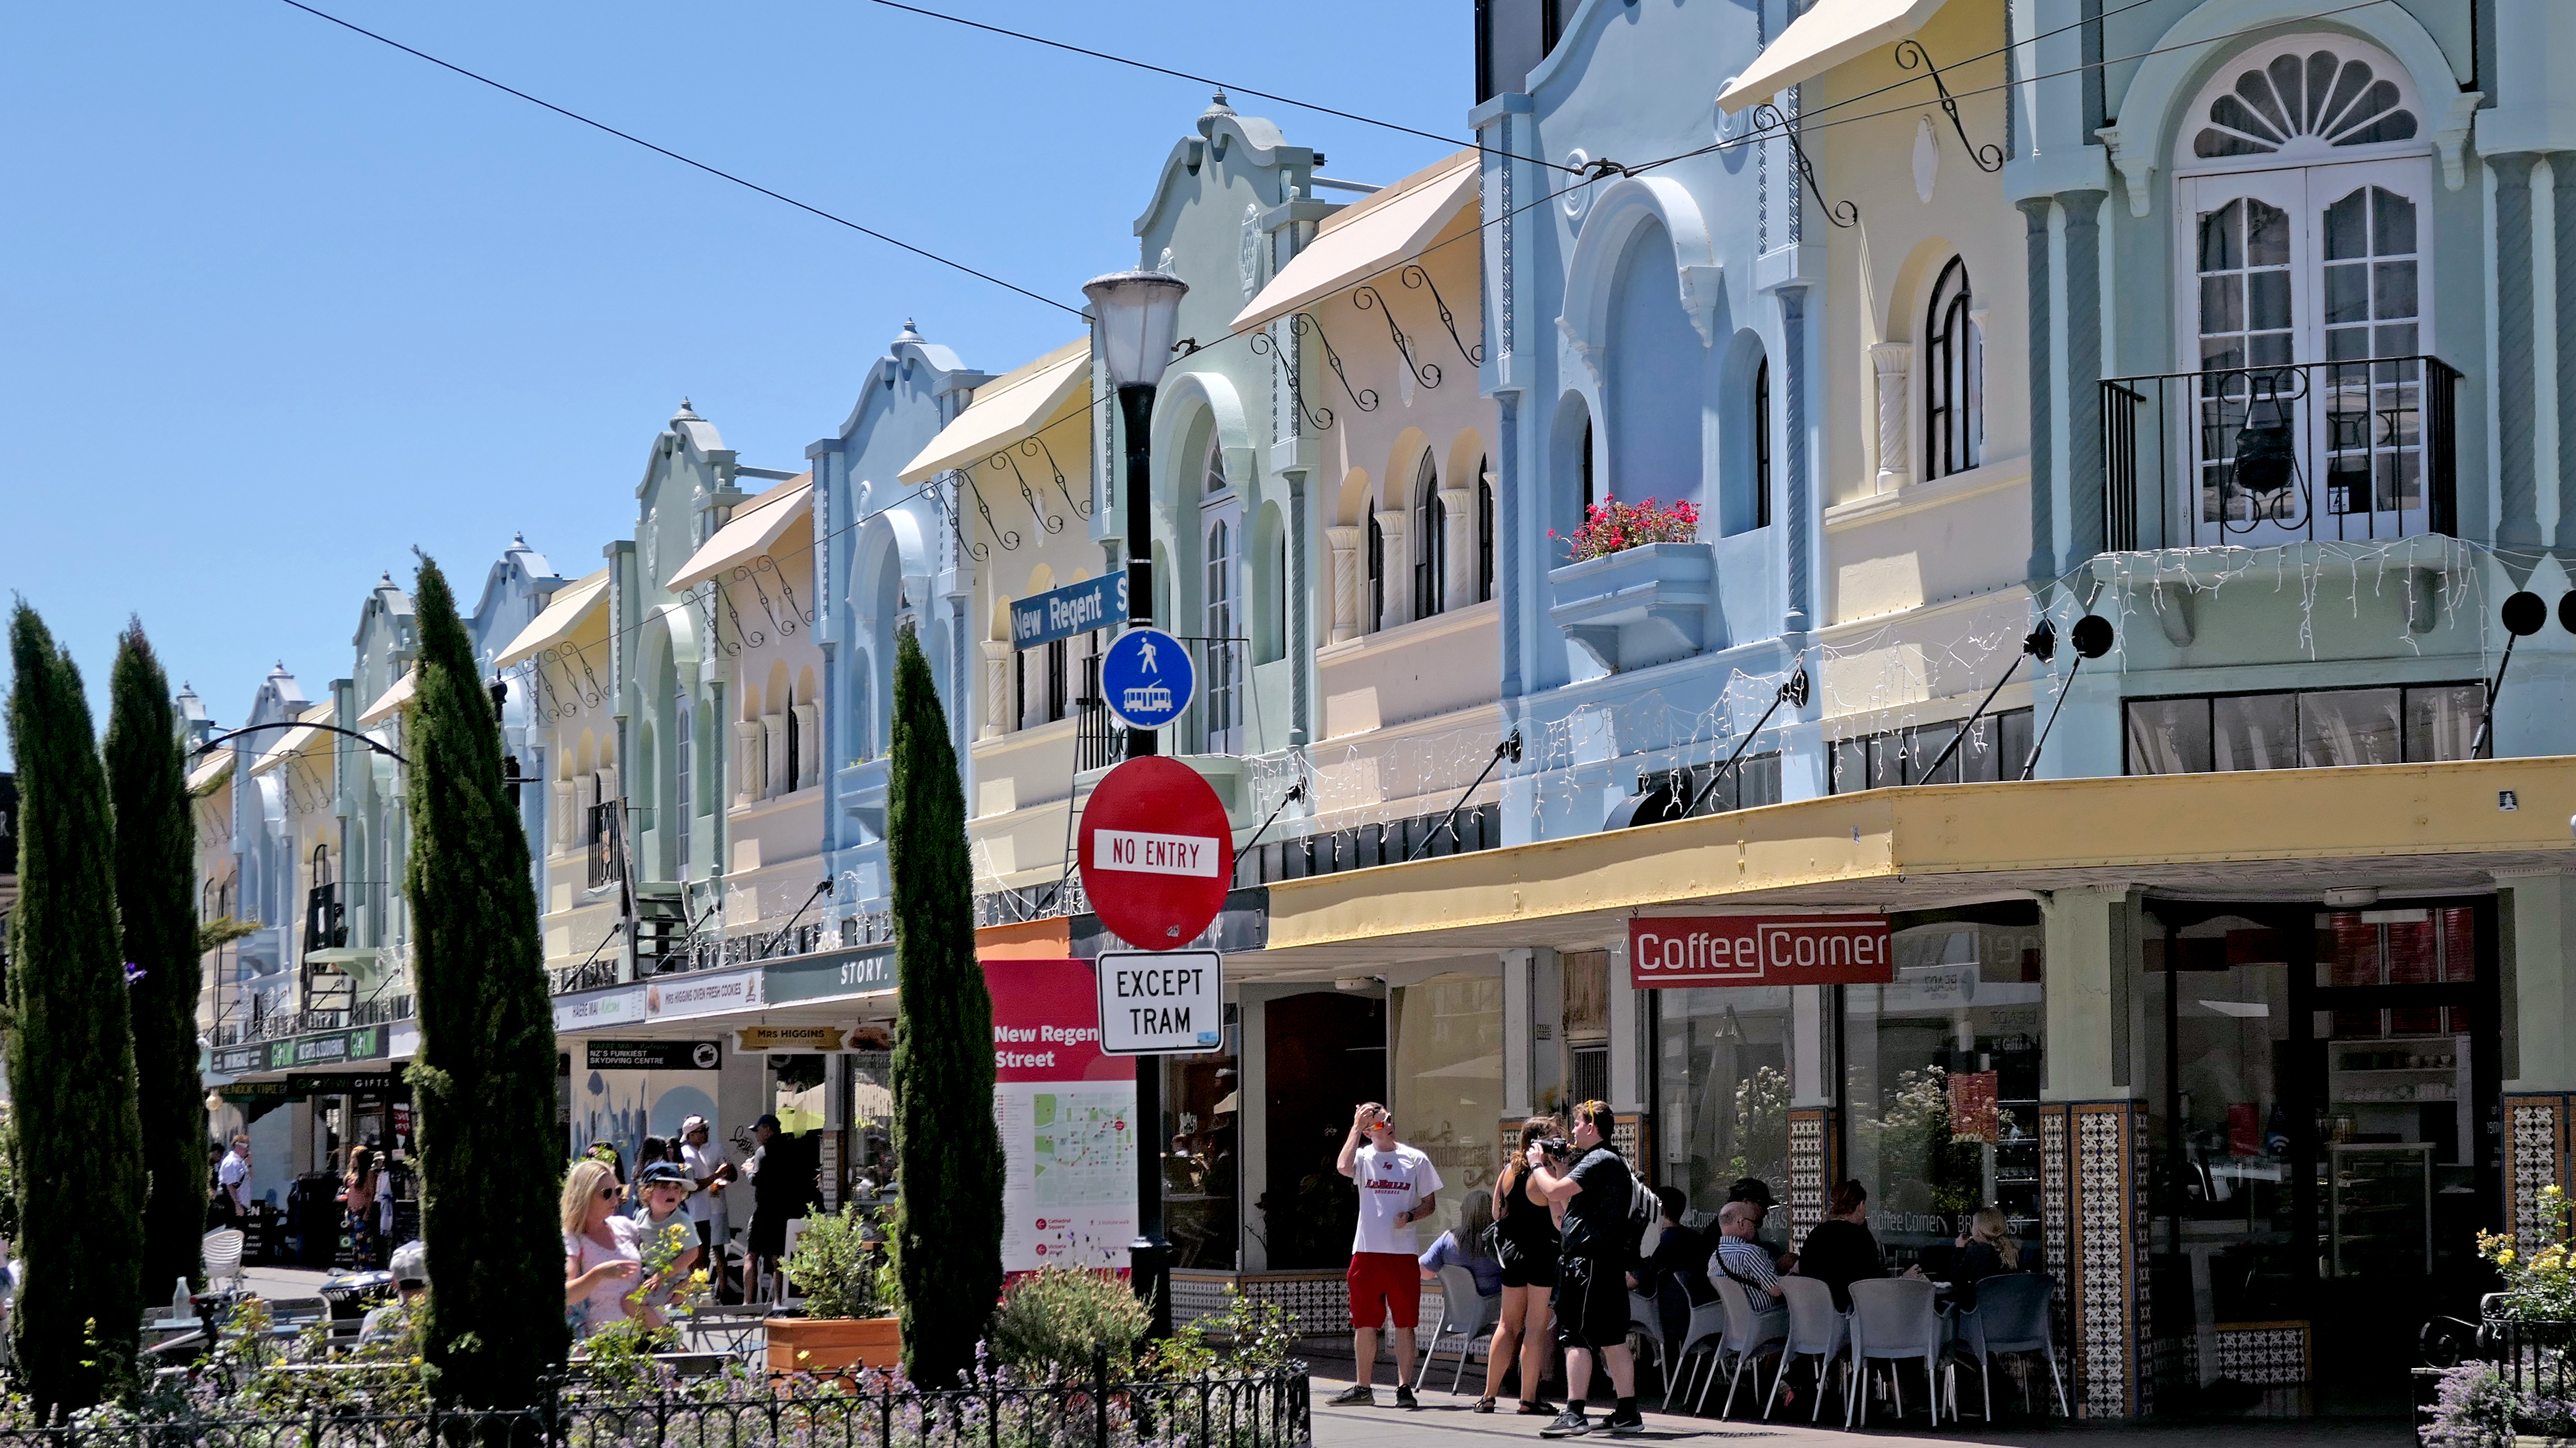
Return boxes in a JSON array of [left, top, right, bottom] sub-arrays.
[[1525, 1100, 1646, 1438]]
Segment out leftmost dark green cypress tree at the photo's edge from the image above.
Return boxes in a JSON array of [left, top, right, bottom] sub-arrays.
[[0, 603, 144, 1415]]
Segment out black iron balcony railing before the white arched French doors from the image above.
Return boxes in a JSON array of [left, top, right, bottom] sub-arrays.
[[2102, 356, 2460, 554]]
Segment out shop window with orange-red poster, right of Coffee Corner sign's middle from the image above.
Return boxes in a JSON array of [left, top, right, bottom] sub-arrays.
[[1837, 904, 2045, 1268]]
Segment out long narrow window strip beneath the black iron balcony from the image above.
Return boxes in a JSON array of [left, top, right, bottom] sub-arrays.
[[2125, 683, 2486, 776]]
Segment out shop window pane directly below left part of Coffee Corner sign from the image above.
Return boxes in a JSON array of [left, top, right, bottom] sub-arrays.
[[1651, 984, 1790, 1219]]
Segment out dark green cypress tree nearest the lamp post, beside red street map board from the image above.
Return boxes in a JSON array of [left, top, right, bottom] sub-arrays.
[[886, 631, 1002, 1386]]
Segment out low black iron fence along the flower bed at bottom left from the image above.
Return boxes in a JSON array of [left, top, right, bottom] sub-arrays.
[[0, 1371, 1314, 1448]]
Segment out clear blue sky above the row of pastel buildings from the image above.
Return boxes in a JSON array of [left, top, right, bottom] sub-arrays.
[[0, 0, 1474, 768]]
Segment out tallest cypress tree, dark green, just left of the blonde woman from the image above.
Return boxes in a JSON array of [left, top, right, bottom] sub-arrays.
[[402, 559, 567, 1409]]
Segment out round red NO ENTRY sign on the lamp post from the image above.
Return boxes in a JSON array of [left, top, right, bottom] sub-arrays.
[[1074, 755, 1234, 951]]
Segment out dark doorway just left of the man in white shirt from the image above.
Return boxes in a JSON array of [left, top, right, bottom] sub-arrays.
[[1257, 989, 1386, 1270]]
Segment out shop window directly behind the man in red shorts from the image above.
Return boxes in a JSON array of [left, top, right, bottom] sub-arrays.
[[1389, 974, 1502, 1245]]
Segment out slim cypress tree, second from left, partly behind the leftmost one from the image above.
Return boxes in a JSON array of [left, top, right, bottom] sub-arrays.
[[108, 619, 206, 1291]]
